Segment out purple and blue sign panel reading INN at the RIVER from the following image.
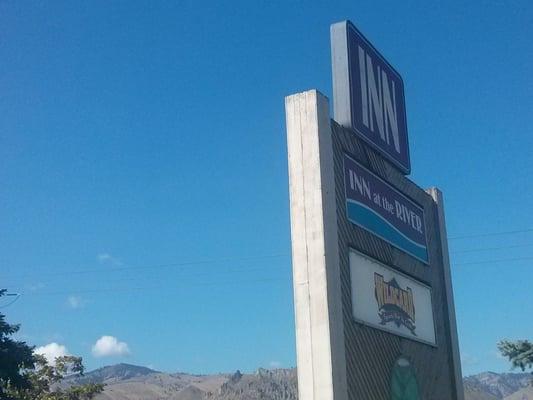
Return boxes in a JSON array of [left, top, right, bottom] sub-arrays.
[[344, 154, 429, 264]]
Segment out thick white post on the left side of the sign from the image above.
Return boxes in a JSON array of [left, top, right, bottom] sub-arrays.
[[285, 91, 348, 400]]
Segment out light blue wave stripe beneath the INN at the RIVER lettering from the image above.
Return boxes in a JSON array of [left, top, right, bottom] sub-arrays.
[[346, 201, 429, 263]]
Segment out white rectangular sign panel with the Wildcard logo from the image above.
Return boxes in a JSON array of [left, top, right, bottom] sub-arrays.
[[350, 250, 436, 345]]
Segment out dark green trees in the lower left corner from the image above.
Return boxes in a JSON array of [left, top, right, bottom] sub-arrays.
[[0, 290, 103, 400]]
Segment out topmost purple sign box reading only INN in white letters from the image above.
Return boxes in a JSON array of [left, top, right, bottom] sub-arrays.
[[331, 21, 411, 174]]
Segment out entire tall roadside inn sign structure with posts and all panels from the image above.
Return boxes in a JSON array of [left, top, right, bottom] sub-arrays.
[[285, 21, 464, 400]]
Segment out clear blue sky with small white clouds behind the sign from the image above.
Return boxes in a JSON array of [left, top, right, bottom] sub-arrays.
[[0, 1, 533, 374]]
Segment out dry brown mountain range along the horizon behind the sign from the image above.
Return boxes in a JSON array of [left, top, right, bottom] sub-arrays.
[[64, 364, 533, 400]]
